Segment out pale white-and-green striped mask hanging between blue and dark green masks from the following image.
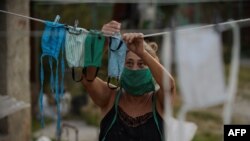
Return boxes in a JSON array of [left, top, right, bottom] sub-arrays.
[[65, 26, 87, 82]]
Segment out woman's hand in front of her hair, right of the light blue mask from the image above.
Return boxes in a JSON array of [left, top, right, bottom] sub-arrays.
[[123, 33, 145, 57]]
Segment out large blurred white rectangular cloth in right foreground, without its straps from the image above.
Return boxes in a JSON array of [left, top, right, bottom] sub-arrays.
[[175, 27, 226, 109]]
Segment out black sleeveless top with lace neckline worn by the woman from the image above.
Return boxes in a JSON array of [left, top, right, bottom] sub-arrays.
[[99, 92, 163, 141]]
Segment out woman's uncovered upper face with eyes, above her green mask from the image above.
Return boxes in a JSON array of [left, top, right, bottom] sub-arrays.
[[125, 51, 147, 70]]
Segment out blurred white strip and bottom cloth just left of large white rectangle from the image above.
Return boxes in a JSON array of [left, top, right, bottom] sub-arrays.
[[162, 29, 198, 141]]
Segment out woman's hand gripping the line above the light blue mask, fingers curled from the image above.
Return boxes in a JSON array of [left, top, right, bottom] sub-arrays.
[[102, 21, 121, 36]]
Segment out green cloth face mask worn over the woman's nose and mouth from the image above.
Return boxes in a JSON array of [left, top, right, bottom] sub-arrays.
[[120, 68, 155, 96]]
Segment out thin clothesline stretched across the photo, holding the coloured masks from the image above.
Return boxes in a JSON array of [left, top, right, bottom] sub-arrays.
[[0, 10, 250, 38]]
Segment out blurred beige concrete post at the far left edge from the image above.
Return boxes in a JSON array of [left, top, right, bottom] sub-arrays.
[[0, 0, 31, 141]]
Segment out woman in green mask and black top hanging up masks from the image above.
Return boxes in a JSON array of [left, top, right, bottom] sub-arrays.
[[82, 21, 175, 141]]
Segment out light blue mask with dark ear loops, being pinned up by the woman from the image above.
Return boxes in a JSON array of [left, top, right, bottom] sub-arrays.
[[108, 34, 127, 87]]
